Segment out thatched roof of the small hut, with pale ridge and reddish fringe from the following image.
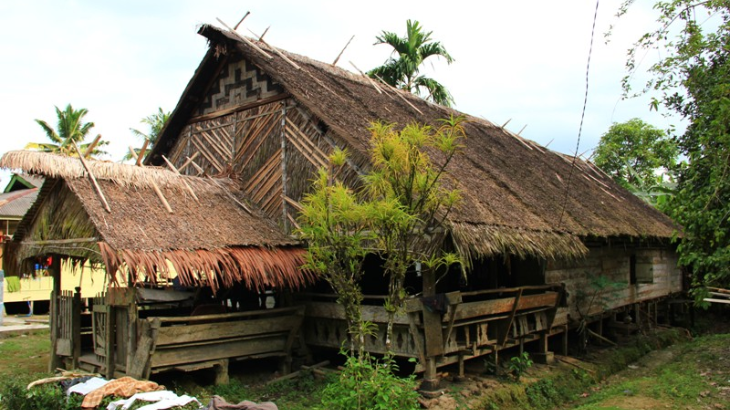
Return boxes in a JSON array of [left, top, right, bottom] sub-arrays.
[[0, 151, 314, 289]]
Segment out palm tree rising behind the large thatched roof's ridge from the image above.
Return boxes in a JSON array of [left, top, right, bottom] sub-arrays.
[[368, 20, 454, 107]]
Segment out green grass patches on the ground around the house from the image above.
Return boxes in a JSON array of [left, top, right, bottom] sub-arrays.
[[0, 331, 730, 410]]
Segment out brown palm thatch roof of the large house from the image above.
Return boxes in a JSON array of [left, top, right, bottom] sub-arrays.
[[149, 25, 677, 258]]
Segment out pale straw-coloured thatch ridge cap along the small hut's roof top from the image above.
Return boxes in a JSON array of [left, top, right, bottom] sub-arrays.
[[0, 151, 212, 190]]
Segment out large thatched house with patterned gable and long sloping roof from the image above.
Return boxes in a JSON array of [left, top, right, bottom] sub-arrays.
[[148, 25, 681, 390]]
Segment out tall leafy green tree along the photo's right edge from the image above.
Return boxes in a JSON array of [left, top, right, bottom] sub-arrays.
[[624, 0, 730, 301]]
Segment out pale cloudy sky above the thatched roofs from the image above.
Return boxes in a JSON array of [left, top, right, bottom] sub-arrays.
[[0, 0, 669, 185]]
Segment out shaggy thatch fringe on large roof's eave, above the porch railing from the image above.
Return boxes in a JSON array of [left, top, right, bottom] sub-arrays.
[[452, 222, 588, 260]]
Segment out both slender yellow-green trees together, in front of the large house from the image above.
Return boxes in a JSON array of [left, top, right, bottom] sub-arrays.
[[298, 117, 464, 356]]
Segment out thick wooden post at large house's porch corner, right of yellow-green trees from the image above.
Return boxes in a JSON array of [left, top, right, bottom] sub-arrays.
[[421, 269, 444, 391]]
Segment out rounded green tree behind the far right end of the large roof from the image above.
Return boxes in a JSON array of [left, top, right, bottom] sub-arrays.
[[593, 118, 678, 187]]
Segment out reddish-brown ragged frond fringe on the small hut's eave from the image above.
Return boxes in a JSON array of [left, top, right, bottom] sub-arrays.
[[98, 242, 315, 292]]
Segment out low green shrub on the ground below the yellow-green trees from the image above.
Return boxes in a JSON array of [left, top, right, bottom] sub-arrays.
[[322, 354, 420, 410]]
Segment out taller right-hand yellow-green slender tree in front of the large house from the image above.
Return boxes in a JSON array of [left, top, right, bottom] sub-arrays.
[[364, 117, 465, 350]]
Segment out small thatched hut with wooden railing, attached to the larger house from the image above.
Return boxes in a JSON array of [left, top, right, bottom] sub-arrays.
[[0, 151, 314, 382]]
